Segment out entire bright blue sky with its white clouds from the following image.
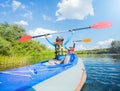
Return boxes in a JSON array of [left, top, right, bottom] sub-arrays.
[[0, 0, 120, 50]]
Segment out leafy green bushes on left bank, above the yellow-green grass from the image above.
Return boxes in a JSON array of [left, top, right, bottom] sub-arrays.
[[0, 22, 48, 56]]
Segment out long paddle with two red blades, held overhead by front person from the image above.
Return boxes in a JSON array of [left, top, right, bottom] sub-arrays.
[[19, 21, 112, 42]]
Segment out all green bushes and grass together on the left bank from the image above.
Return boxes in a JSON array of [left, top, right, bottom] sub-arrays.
[[0, 22, 54, 70]]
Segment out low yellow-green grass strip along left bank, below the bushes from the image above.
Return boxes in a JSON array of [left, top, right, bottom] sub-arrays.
[[0, 51, 54, 71]]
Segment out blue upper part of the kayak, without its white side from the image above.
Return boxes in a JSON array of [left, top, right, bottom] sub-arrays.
[[0, 56, 80, 91]]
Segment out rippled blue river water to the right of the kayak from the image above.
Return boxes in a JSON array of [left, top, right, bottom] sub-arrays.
[[81, 56, 120, 91]]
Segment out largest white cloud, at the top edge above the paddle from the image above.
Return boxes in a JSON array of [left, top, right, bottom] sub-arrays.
[[56, 0, 94, 21]]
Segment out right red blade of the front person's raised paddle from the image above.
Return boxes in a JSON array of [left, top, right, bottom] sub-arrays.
[[91, 21, 112, 29]]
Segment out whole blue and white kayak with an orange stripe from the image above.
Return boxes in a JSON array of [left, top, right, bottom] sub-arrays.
[[0, 55, 86, 91]]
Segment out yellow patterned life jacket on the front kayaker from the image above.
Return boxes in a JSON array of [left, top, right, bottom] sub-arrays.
[[55, 44, 68, 56]]
